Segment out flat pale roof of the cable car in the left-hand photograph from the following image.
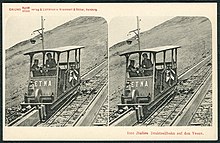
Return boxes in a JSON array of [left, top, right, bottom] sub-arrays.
[[24, 46, 85, 55]]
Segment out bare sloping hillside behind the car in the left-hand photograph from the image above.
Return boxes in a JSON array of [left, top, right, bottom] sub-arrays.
[[5, 16, 108, 106]]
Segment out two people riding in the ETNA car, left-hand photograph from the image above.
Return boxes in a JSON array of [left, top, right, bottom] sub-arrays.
[[31, 53, 56, 77]]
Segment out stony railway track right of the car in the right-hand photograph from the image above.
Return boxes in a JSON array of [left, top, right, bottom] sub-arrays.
[[143, 58, 211, 126]]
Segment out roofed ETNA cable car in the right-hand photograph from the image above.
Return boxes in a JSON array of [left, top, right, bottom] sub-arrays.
[[118, 46, 180, 106]]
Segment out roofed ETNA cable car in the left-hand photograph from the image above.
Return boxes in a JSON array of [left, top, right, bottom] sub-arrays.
[[21, 46, 84, 107]]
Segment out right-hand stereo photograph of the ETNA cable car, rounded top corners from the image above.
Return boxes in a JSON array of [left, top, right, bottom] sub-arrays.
[[109, 16, 213, 126]]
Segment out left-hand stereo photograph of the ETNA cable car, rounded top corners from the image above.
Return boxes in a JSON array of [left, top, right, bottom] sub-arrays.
[[5, 16, 108, 127]]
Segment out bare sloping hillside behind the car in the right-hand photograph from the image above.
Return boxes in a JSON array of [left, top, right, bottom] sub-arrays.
[[109, 17, 212, 110]]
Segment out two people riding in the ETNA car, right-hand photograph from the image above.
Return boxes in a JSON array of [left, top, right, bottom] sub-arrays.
[[127, 53, 153, 77]]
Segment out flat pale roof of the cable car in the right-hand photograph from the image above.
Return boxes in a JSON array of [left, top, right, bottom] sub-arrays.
[[119, 45, 180, 56]]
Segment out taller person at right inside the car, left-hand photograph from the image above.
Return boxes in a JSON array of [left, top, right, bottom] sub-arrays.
[[46, 53, 56, 76]]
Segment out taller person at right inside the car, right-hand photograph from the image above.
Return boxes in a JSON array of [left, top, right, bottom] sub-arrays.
[[142, 53, 153, 76]]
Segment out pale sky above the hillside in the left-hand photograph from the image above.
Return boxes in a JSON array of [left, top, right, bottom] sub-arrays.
[[4, 16, 76, 49]]
